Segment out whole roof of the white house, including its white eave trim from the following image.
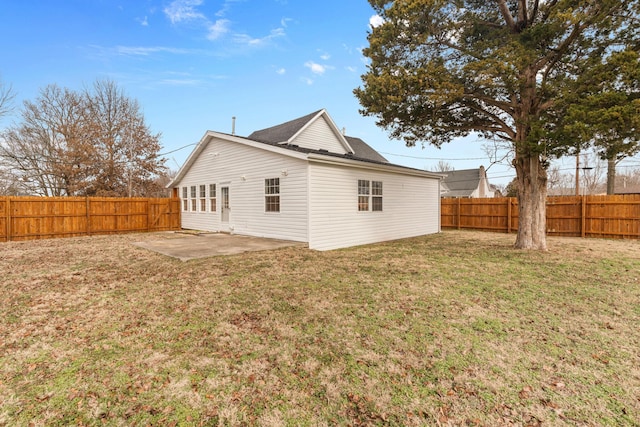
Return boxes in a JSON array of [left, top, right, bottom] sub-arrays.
[[167, 109, 436, 187]]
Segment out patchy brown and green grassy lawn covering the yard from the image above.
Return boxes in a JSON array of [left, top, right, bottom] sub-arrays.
[[0, 231, 640, 426]]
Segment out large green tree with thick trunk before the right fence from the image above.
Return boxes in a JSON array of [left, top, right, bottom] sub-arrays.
[[354, 0, 640, 250]]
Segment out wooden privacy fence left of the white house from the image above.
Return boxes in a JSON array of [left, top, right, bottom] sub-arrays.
[[0, 197, 180, 242]]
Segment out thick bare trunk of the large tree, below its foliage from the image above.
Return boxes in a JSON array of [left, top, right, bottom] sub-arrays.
[[514, 154, 547, 250]]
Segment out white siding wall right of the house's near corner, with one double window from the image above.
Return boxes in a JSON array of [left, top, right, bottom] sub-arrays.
[[309, 163, 440, 250]]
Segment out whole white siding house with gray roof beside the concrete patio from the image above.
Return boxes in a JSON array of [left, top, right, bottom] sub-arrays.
[[169, 110, 442, 250]]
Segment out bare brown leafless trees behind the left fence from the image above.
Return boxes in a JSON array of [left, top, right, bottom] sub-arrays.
[[0, 80, 167, 197]]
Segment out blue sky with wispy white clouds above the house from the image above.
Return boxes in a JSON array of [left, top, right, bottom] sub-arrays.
[[0, 0, 514, 184]]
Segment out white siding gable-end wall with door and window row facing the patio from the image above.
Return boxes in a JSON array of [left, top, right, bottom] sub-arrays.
[[177, 139, 308, 242]]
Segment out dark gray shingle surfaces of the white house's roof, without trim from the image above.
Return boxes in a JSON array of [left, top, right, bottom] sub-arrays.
[[247, 110, 388, 163]]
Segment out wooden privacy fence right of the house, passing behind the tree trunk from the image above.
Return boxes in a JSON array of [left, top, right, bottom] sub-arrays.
[[441, 194, 640, 239]]
